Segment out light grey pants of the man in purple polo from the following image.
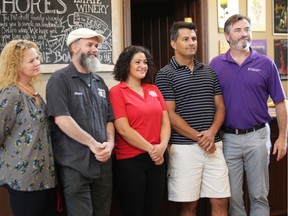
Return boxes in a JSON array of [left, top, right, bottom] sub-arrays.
[[222, 124, 271, 216]]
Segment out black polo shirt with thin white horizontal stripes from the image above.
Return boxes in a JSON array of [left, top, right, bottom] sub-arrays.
[[155, 56, 222, 145]]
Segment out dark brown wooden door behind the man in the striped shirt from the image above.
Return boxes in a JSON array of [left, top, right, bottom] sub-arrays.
[[124, 0, 208, 68]]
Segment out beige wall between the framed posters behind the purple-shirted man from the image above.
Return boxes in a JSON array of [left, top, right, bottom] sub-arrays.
[[208, 0, 288, 96]]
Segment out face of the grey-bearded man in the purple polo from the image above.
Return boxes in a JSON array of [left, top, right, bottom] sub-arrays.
[[225, 19, 252, 51]]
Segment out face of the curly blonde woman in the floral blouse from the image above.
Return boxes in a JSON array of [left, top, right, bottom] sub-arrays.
[[19, 48, 40, 80]]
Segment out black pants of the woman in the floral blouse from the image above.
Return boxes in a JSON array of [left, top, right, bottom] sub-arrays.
[[8, 187, 57, 216]]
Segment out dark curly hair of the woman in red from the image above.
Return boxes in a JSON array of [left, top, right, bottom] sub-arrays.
[[113, 45, 156, 83]]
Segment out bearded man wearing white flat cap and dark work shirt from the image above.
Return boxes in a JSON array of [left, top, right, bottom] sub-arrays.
[[46, 28, 115, 216]]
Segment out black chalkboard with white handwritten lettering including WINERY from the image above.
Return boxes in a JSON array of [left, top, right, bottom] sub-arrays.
[[0, 0, 113, 65]]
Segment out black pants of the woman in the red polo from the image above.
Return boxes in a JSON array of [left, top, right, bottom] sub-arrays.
[[114, 154, 165, 216]]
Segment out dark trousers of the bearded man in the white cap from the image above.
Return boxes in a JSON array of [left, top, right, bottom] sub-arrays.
[[59, 158, 112, 216]]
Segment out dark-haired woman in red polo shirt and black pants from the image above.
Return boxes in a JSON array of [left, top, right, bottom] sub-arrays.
[[110, 46, 170, 216]]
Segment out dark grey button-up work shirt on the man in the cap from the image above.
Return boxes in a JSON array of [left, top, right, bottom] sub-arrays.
[[46, 63, 114, 178]]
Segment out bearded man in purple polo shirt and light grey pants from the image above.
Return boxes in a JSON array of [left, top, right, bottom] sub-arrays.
[[210, 14, 287, 216]]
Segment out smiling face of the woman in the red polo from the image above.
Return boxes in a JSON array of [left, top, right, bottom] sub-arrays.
[[128, 52, 148, 80]]
